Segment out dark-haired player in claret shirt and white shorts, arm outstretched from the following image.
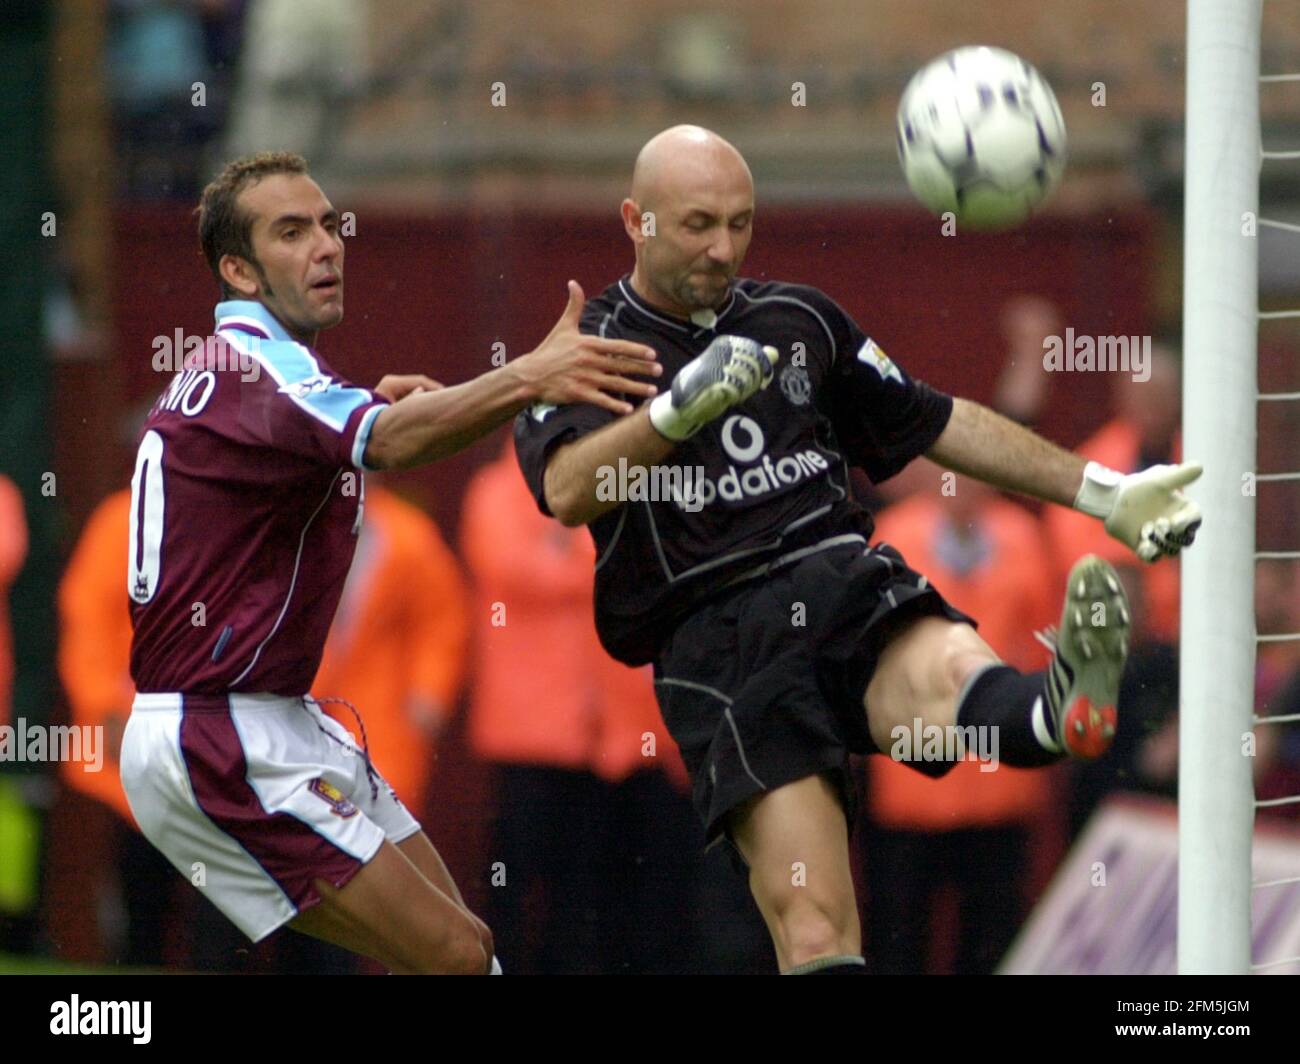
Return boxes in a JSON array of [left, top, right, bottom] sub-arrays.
[[121, 153, 659, 973]]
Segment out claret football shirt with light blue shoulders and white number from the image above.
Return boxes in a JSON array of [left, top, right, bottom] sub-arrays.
[[126, 300, 386, 695]]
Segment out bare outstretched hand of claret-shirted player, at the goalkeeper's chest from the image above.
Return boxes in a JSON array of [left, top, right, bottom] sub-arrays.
[[516, 281, 663, 414]]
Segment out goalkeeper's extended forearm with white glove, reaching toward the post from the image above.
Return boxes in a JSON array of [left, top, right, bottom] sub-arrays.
[[926, 398, 1201, 562]]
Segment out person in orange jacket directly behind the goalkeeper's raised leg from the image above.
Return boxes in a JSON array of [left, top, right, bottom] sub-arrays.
[[865, 466, 1060, 974]]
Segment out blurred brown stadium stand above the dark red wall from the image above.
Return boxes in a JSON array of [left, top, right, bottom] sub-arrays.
[[76, 0, 1300, 202]]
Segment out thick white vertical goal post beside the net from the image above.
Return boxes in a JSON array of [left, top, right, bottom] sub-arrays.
[[1178, 0, 1261, 974]]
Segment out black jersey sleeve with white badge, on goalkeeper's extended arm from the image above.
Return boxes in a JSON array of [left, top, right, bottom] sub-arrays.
[[818, 293, 953, 484]]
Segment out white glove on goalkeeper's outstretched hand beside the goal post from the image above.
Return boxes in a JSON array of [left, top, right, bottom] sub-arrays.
[[1074, 462, 1201, 562]]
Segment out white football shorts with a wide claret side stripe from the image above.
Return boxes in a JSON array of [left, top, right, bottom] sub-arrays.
[[121, 695, 420, 942]]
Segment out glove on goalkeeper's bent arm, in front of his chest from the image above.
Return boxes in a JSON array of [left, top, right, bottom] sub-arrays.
[[650, 336, 779, 441]]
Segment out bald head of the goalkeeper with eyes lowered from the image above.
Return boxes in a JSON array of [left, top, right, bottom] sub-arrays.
[[623, 126, 754, 317]]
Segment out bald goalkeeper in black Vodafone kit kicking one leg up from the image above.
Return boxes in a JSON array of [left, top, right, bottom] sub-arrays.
[[515, 126, 1200, 974]]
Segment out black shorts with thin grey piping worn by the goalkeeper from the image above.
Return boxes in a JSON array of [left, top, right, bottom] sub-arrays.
[[655, 542, 975, 845]]
